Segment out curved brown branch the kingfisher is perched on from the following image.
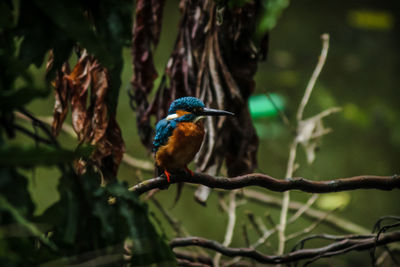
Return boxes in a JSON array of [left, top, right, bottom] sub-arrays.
[[129, 173, 400, 195]]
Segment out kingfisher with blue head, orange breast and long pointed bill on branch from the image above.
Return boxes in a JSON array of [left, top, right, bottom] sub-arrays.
[[153, 97, 234, 182]]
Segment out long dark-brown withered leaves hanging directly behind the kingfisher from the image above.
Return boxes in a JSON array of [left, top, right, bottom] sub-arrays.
[[132, 0, 265, 204]]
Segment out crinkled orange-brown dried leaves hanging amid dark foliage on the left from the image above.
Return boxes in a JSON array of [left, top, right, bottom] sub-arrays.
[[50, 50, 125, 182]]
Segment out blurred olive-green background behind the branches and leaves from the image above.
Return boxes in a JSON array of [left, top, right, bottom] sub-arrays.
[[18, 0, 400, 266]]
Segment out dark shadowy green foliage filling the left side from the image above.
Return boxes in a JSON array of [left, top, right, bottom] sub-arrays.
[[0, 0, 174, 266]]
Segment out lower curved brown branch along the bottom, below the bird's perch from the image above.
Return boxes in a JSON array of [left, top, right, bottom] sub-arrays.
[[170, 231, 400, 264]]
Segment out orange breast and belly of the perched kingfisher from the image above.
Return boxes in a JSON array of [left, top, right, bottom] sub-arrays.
[[156, 121, 204, 172]]
